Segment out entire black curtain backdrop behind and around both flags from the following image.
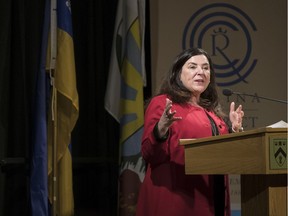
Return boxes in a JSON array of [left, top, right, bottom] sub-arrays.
[[0, 0, 150, 216]]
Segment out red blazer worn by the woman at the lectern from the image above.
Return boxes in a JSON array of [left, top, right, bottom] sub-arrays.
[[136, 95, 231, 216]]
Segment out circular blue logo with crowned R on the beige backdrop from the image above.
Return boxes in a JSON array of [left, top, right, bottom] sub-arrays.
[[182, 3, 257, 86]]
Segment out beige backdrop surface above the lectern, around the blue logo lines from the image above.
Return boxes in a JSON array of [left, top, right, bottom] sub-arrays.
[[150, 0, 287, 130]]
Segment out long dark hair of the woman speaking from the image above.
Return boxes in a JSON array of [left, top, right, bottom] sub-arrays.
[[156, 48, 225, 117]]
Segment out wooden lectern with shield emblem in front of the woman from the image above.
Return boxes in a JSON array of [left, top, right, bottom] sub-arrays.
[[180, 128, 287, 216]]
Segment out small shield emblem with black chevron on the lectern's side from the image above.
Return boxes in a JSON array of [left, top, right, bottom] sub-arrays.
[[270, 138, 287, 169]]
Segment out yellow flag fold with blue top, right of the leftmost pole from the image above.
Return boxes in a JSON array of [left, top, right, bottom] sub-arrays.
[[46, 0, 79, 216]]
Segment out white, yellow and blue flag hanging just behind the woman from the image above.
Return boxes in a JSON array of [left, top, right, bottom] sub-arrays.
[[105, 0, 146, 216]]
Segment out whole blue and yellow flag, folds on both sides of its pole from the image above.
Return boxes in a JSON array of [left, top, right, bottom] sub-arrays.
[[30, 0, 79, 216]]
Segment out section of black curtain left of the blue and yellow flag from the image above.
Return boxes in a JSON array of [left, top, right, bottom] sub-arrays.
[[0, 0, 43, 215]]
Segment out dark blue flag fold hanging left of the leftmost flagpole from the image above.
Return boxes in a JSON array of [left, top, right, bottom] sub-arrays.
[[30, 1, 50, 216]]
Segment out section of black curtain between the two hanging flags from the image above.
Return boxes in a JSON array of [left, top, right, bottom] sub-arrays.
[[71, 0, 119, 216]]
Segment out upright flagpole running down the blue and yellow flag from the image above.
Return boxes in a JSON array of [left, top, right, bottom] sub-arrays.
[[50, 0, 58, 216]]
